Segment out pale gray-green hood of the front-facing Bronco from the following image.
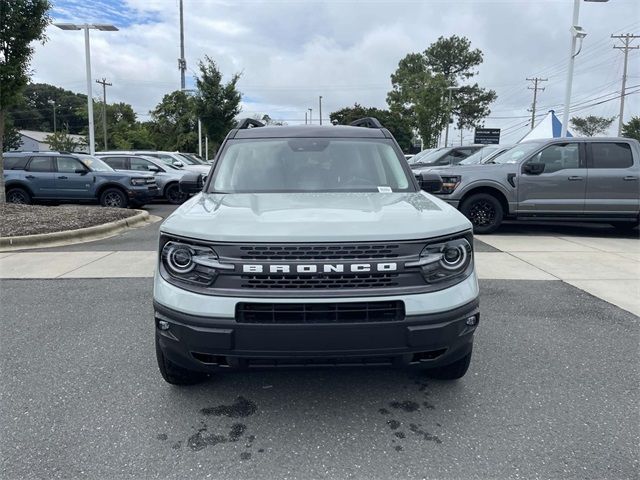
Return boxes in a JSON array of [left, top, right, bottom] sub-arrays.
[[161, 192, 471, 243]]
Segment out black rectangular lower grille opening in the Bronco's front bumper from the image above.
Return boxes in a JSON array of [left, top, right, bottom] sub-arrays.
[[236, 301, 404, 324]]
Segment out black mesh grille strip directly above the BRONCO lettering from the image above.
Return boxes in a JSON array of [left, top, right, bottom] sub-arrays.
[[239, 243, 400, 261]]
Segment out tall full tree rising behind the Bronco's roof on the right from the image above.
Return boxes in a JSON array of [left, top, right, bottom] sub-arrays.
[[387, 35, 497, 147]]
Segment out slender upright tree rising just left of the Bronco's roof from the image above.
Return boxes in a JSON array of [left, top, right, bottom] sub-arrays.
[[196, 56, 242, 151]]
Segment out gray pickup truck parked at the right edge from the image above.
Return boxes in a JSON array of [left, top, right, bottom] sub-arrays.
[[424, 138, 640, 233]]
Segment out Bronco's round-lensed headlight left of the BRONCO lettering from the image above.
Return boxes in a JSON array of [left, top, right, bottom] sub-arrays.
[[160, 240, 235, 286]]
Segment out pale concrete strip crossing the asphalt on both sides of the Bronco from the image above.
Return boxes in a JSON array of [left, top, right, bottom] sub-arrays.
[[0, 235, 640, 316]]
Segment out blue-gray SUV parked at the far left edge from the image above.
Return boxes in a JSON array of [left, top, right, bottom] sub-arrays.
[[3, 152, 158, 208]]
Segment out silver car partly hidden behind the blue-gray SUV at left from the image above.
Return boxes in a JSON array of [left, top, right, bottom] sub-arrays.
[[96, 153, 188, 205]]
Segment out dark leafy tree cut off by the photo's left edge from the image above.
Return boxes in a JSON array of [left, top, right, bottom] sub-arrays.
[[0, 0, 51, 204]]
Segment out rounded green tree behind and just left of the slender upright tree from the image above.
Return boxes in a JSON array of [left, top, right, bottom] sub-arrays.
[[151, 90, 198, 152]]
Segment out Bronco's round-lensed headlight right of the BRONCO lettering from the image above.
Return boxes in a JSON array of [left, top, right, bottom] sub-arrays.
[[416, 238, 473, 283]]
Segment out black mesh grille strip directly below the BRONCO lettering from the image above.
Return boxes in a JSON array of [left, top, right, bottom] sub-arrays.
[[241, 273, 399, 290]]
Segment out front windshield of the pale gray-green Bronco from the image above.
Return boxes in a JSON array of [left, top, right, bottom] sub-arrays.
[[210, 138, 415, 193]]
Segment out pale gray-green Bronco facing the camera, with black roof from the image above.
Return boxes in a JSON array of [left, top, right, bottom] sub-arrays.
[[153, 118, 479, 385]]
